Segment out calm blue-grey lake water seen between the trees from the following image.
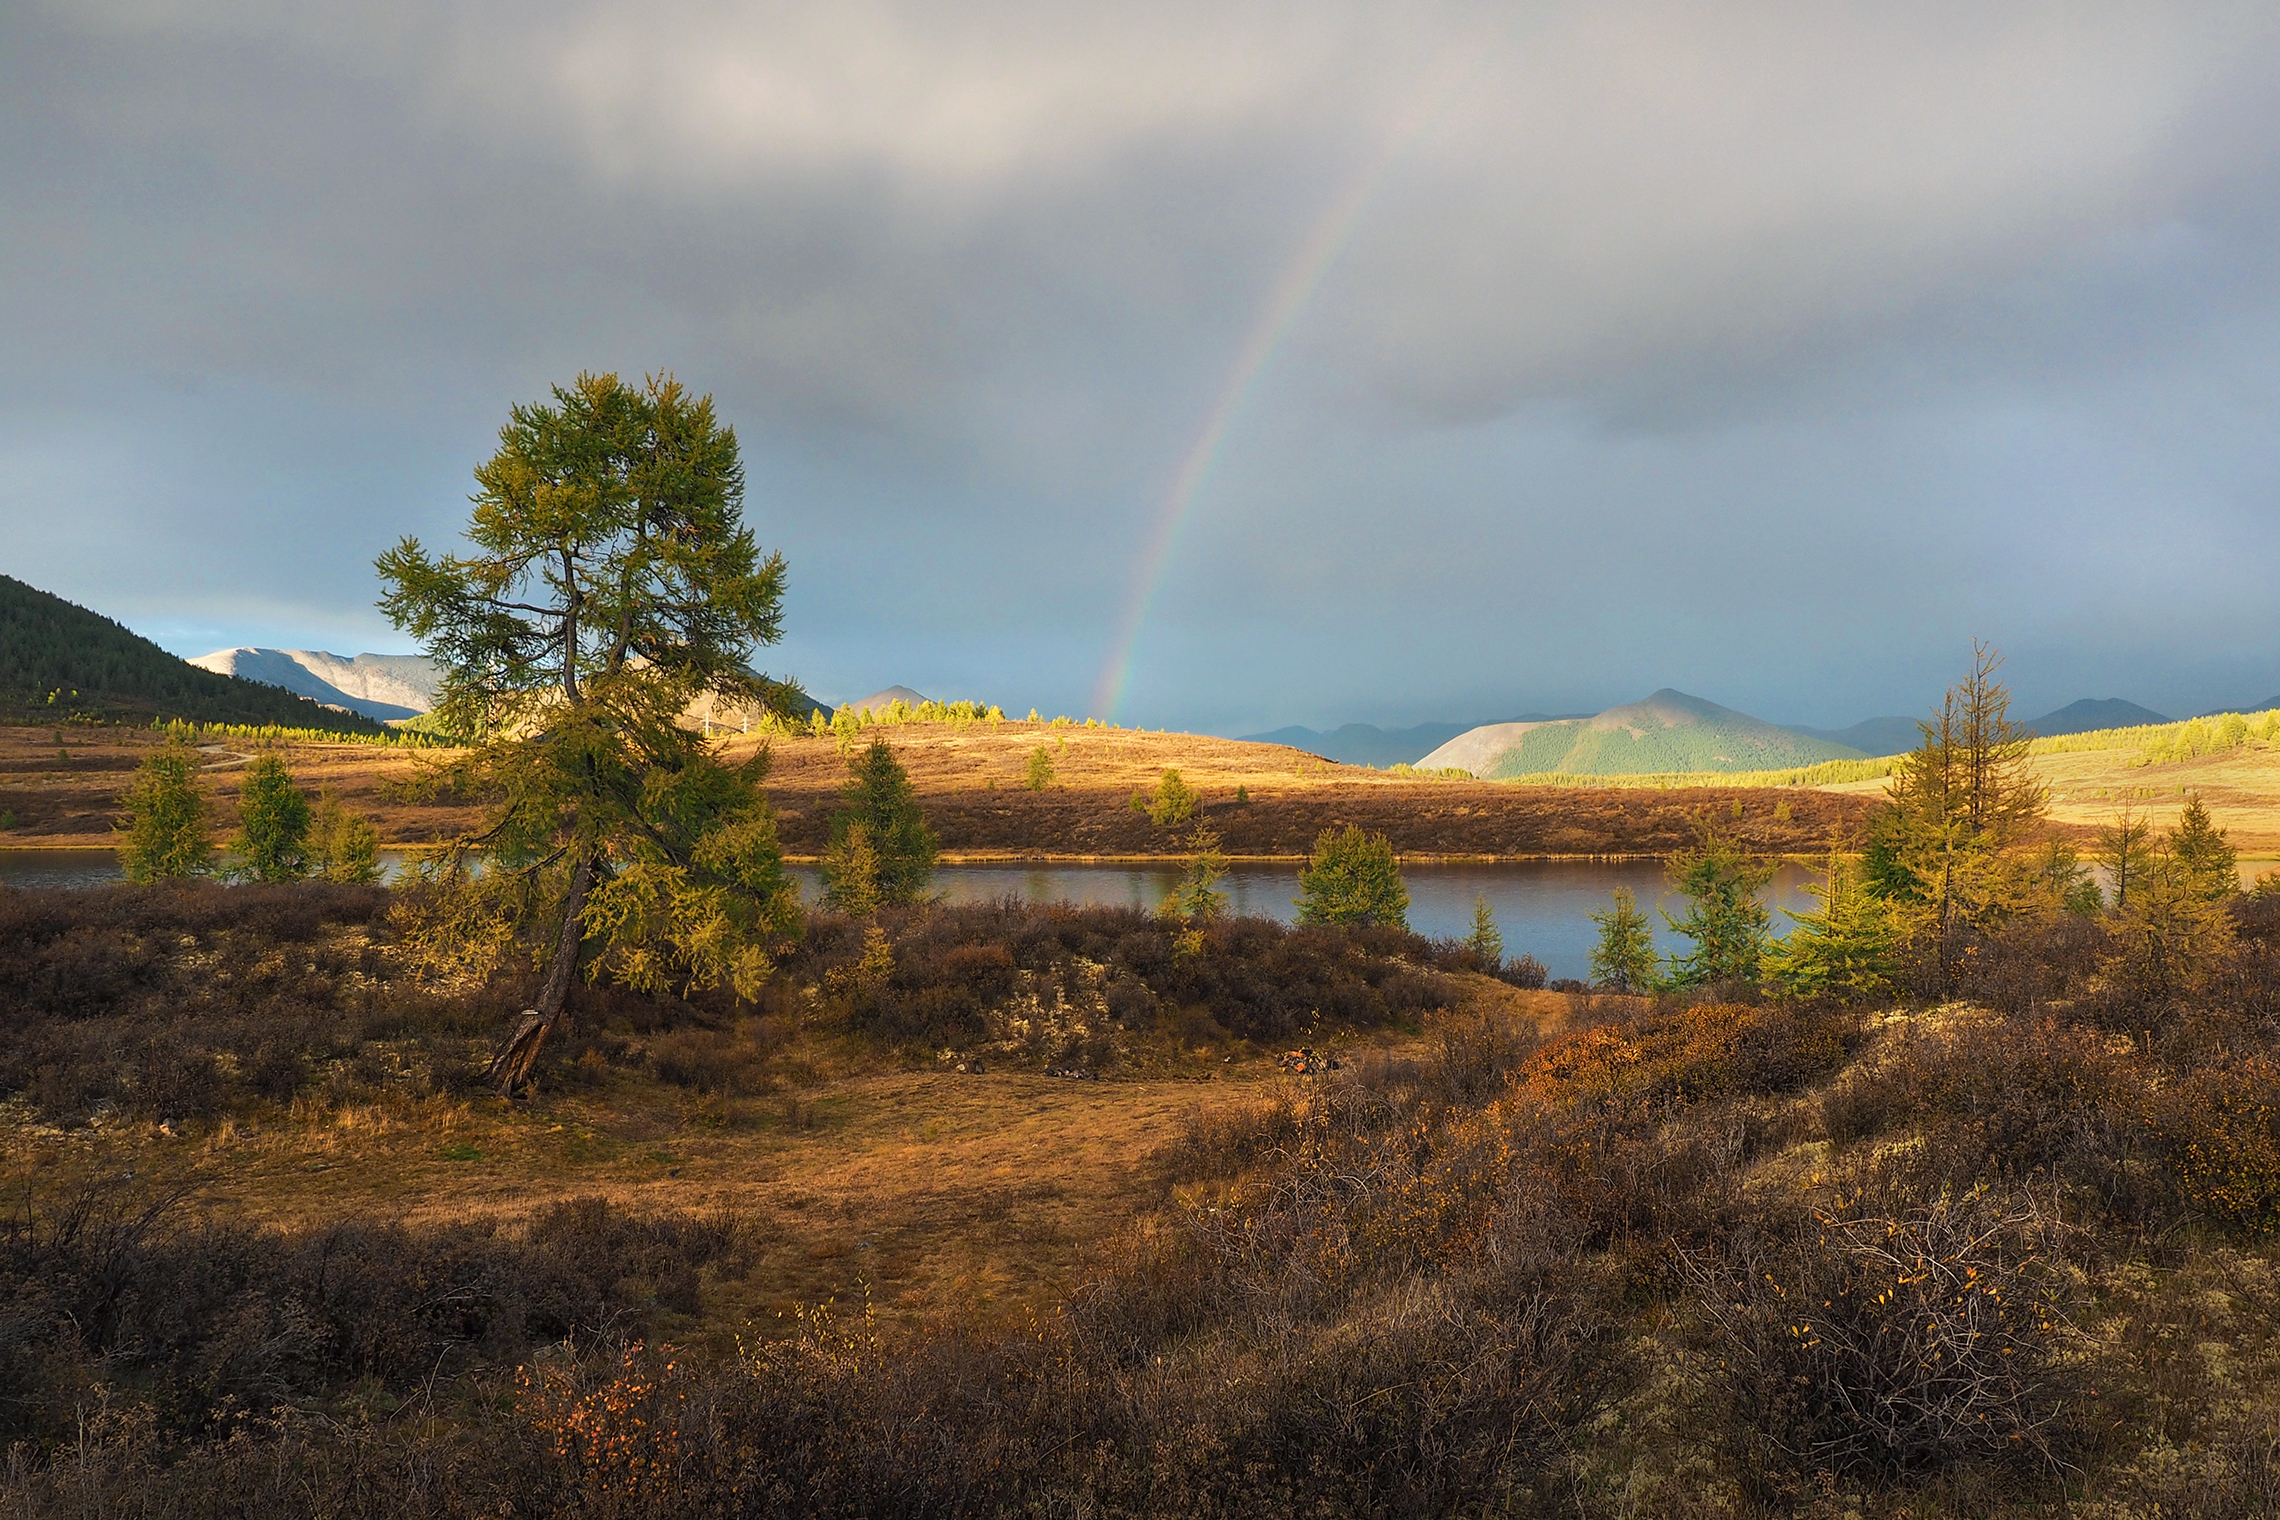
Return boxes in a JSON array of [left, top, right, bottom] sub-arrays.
[[0, 850, 1817, 978]]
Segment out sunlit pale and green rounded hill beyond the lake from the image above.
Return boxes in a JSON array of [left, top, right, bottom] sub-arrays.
[[1418, 688, 1860, 779]]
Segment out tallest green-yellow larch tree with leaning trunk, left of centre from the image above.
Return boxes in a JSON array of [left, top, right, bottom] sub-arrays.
[[378, 374, 798, 1092]]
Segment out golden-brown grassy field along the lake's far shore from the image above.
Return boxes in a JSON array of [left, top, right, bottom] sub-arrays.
[[0, 722, 2280, 861]]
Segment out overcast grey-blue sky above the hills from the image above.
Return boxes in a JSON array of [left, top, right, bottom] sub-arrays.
[[0, 0, 2280, 732]]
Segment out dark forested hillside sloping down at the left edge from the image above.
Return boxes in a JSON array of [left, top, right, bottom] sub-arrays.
[[0, 574, 383, 734]]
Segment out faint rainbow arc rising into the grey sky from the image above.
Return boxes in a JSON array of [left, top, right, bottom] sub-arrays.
[[1092, 130, 1414, 722]]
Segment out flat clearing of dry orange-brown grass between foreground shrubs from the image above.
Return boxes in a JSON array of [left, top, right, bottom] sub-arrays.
[[0, 1002, 1569, 1333]]
